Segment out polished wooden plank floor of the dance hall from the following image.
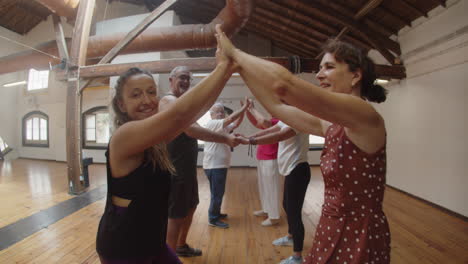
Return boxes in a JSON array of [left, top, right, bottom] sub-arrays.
[[0, 159, 468, 264]]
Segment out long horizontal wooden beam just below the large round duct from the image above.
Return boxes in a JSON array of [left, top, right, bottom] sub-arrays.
[[80, 57, 406, 79]]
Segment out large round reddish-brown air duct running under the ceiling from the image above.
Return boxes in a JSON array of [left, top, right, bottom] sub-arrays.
[[0, 0, 254, 74]]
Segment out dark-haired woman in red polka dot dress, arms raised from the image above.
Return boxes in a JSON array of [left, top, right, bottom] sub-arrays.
[[217, 27, 390, 264]]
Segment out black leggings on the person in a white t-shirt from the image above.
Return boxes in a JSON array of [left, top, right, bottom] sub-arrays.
[[283, 162, 310, 252]]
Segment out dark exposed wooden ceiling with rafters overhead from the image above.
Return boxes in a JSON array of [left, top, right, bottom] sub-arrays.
[[0, 0, 446, 64]]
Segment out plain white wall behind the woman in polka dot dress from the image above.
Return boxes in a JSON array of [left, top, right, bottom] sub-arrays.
[[378, 0, 468, 216]]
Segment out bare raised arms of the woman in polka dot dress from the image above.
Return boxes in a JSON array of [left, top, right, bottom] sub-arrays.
[[217, 27, 383, 136]]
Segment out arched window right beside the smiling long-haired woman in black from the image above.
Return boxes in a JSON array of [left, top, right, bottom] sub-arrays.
[[82, 106, 110, 149]]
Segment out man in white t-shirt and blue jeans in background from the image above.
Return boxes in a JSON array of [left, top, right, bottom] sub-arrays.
[[203, 103, 249, 228]]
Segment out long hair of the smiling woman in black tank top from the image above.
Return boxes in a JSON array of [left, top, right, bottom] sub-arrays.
[[112, 68, 175, 174]]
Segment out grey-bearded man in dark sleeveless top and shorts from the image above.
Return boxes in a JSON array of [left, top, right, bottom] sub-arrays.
[[159, 66, 238, 257]]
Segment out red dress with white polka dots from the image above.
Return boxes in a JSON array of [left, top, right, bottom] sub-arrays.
[[304, 125, 390, 264]]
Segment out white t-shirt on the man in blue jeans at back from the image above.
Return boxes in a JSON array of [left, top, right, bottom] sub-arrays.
[[203, 119, 231, 169]]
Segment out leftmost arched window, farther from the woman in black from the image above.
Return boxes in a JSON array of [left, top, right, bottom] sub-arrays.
[[23, 111, 49, 148]]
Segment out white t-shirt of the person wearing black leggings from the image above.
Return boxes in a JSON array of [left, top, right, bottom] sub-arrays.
[[276, 121, 309, 176]]
